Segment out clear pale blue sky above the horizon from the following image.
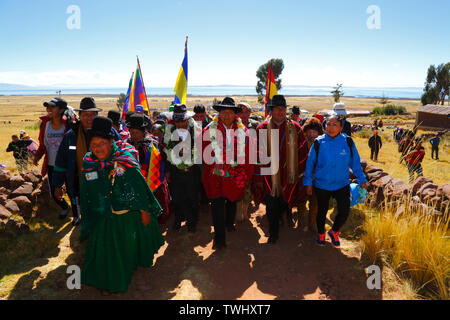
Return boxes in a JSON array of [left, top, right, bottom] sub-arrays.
[[0, 0, 450, 88]]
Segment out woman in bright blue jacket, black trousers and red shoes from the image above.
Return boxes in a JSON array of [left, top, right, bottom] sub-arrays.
[[303, 115, 367, 247]]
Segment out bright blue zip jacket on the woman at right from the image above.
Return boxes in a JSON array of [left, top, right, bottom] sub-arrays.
[[303, 133, 367, 191]]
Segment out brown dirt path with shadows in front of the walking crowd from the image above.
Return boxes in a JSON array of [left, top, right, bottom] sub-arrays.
[[5, 205, 381, 300]]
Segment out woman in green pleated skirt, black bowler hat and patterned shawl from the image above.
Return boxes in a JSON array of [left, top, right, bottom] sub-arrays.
[[80, 117, 164, 293]]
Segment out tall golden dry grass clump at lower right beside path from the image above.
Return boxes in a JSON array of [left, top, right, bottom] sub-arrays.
[[361, 199, 450, 300]]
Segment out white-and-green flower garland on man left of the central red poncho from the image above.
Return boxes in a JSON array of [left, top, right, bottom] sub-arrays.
[[163, 118, 200, 170]]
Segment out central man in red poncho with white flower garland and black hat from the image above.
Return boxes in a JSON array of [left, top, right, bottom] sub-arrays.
[[202, 97, 254, 249]]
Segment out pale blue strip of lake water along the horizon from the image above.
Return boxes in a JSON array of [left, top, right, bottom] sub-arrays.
[[0, 86, 423, 99]]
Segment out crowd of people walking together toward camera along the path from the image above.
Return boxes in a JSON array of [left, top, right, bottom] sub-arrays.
[[35, 95, 367, 292]]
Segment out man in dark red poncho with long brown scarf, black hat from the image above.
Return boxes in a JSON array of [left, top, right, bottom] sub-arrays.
[[252, 95, 308, 243]]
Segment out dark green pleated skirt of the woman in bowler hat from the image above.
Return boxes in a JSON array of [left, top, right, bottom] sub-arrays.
[[81, 211, 164, 292]]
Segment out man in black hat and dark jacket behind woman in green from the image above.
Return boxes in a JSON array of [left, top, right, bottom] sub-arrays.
[[52, 97, 121, 226]]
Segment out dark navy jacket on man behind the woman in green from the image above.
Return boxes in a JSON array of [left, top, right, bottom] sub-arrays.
[[52, 122, 121, 203]]
